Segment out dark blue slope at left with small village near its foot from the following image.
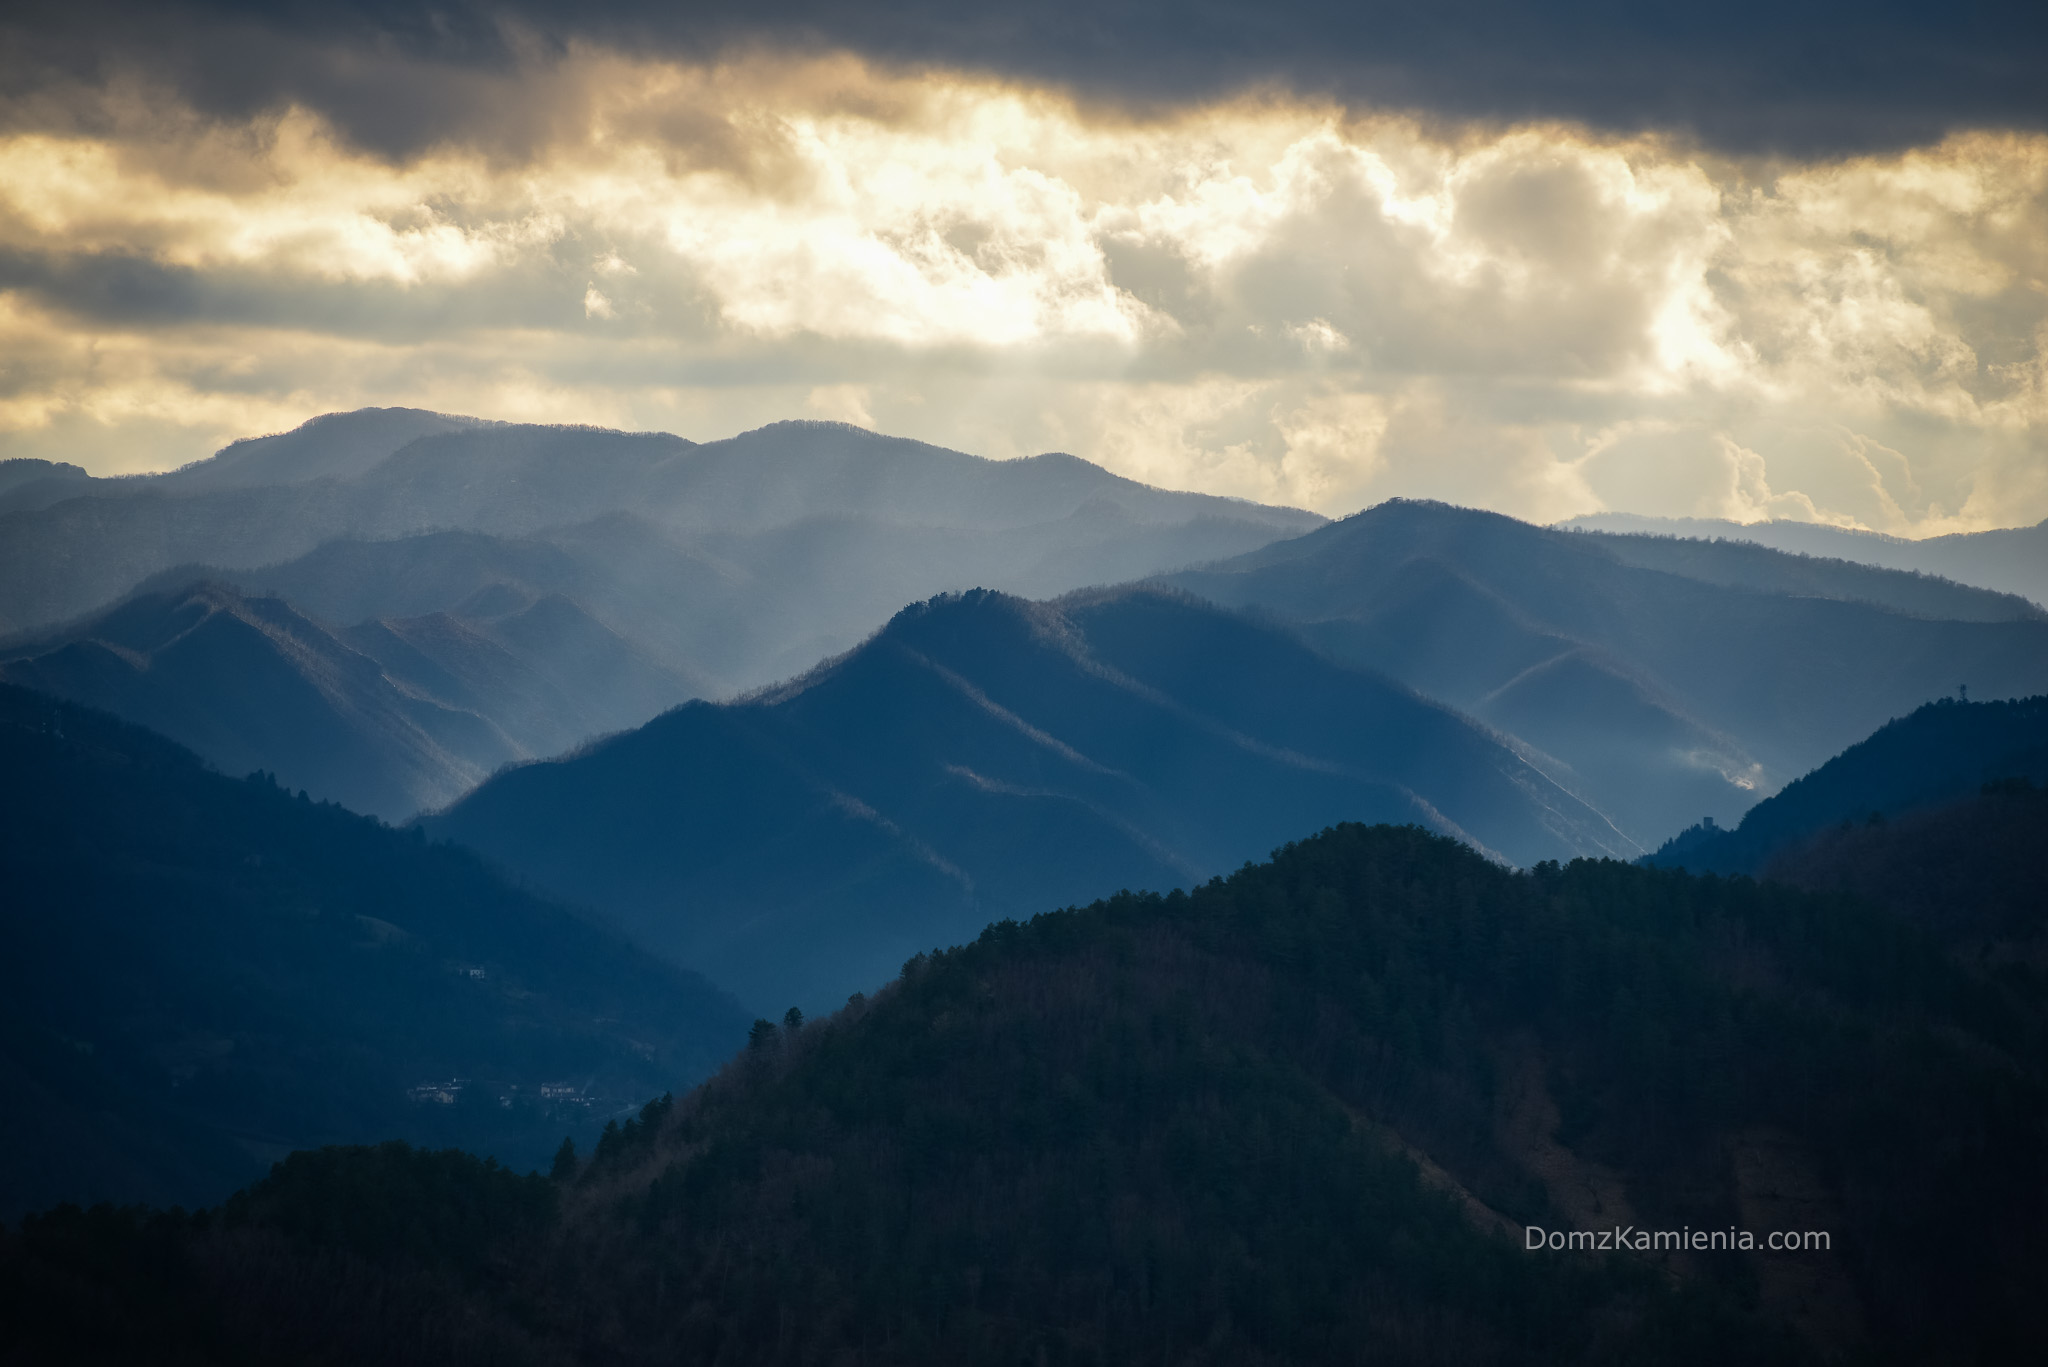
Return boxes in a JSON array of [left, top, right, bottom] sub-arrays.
[[0, 687, 745, 1217]]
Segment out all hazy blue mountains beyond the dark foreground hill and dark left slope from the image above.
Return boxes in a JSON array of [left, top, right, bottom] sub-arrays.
[[12, 410, 2048, 1010]]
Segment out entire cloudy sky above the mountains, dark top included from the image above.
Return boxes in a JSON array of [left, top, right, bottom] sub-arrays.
[[0, 0, 2048, 535]]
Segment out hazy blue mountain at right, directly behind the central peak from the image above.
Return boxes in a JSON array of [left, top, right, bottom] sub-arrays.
[[1167, 502, 2048, 844]]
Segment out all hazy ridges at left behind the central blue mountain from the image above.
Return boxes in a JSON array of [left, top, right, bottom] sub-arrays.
[[0, 410, 1321, 820]]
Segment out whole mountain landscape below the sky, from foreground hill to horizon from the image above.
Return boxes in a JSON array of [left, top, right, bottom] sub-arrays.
[[12, 412, 2048, 1367]]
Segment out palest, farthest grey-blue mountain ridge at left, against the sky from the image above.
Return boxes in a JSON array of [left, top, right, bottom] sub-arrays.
[[0, 410, 1321, 639]]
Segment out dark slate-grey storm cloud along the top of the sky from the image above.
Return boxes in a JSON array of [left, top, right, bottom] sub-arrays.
[[0, 0, 2048, 156]]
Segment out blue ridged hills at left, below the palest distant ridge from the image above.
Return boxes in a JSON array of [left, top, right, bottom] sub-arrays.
[[0, 582, 694, 822]]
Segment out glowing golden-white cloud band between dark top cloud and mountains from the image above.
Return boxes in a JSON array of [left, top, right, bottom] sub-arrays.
[[0, 49, 2048, 533]]
